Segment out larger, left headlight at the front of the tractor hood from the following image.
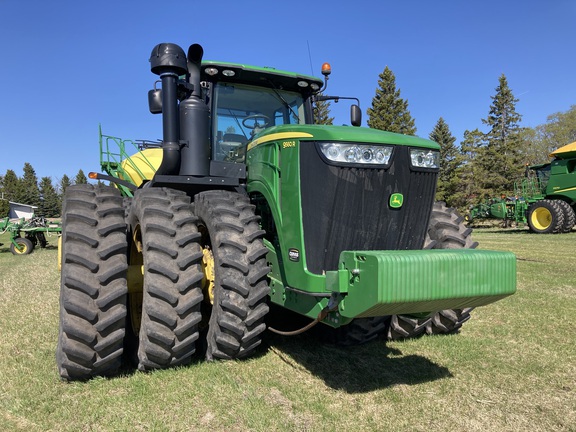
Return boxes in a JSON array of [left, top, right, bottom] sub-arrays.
[[320, 143, 392, 165]]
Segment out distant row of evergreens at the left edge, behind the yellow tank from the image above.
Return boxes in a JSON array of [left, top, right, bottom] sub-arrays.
[[0, 166, 88, 218]]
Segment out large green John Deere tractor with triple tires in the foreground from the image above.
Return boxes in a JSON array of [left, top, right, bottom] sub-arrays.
[[56, 43, 516, 380]]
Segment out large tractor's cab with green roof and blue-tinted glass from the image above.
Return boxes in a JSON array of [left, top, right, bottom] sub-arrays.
[[200, 61, 323, 163]]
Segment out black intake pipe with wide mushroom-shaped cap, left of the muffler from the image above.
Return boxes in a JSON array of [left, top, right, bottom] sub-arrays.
[[150, 43, 188, 175]]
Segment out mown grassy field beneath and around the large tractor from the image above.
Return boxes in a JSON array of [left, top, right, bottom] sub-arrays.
[[0, 230, 576, 432]]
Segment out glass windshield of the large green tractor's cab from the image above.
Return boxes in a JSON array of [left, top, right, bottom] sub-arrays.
[[212, 83, 305, 162]]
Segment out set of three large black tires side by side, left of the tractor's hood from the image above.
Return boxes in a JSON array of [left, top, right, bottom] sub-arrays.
[[56, 185, 269, 380]]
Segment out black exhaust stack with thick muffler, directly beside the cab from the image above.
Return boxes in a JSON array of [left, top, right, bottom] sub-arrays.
[[180, 44, 210, 176]]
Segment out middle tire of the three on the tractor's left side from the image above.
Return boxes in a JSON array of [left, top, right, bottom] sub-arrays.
[[128, 188, 203, 371]]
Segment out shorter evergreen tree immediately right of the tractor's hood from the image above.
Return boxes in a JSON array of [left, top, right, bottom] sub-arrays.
[[429, 117, 461, 207]]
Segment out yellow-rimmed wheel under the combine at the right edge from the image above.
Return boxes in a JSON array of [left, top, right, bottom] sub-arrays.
[[528, 199, 576, 234]]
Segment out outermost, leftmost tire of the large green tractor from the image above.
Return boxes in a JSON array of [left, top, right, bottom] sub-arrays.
[[56, 184, 127, 380]]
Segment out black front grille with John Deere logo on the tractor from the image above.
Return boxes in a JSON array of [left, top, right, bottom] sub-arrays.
[[300, 142, 437, 274]]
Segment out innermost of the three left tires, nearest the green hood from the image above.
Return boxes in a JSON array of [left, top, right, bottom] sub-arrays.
[[194, 190, 270, 360]]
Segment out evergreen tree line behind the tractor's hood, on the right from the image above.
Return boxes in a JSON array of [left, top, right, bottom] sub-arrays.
[[315, 66, 576, 211]]
